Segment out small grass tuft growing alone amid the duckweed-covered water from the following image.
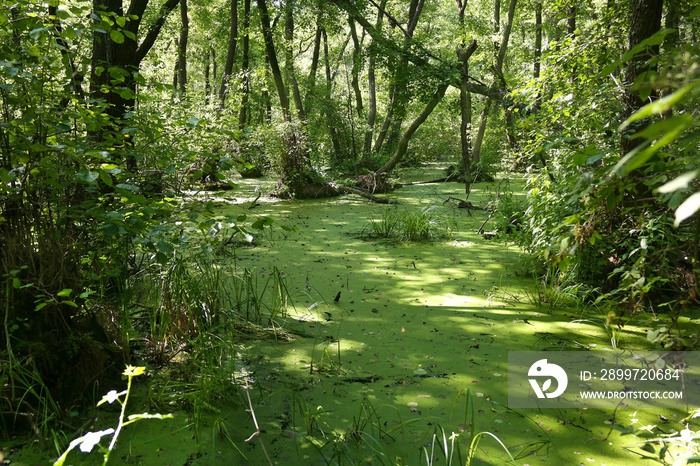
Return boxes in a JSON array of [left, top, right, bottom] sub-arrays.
[[365, 206, 453, 242]]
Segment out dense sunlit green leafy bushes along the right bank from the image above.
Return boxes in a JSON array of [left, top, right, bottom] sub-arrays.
[[499, 21, 698, 319]]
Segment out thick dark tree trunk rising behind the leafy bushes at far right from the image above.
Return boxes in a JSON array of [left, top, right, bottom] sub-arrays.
[[620, 0, 663, 155]]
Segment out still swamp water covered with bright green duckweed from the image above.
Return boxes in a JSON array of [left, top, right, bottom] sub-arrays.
[[11, 169, 696, 466]]
